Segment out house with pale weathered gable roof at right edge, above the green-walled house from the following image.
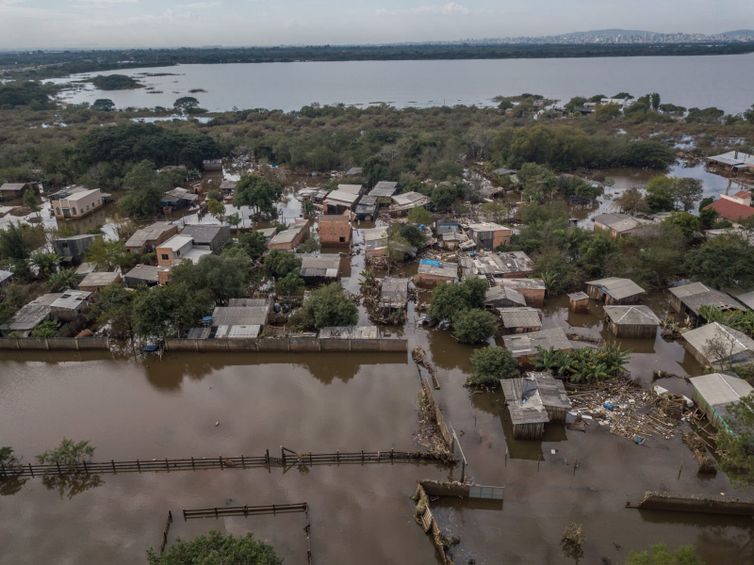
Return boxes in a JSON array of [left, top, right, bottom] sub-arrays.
[[681, 322, 754, 367]]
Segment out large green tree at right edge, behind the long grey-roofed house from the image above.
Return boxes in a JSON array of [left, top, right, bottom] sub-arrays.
[[685, 234, 754, 288]]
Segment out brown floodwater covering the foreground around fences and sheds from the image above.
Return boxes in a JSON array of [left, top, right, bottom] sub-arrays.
[[0, 294, 754, 565]]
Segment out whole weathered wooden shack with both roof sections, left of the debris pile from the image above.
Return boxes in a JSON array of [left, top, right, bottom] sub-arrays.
[[500, 372, 571, 440]]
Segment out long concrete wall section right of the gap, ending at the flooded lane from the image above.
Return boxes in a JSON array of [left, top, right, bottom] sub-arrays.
[[165, 336, 407, 353]]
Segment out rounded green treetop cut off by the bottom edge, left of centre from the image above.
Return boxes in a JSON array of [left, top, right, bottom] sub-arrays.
[[147, 530, 283, 565]]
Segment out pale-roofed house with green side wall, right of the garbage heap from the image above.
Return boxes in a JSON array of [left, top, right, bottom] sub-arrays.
[[689, 373, 754, 431]]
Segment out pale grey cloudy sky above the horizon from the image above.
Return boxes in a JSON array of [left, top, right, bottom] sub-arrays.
[[0, 0, 754, 49]]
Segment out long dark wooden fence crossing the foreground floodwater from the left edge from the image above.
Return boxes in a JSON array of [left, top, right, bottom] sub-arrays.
[[0, 447, 455, 479]]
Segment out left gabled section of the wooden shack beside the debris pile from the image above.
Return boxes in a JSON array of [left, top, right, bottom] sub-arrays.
[[500, 378, 550, 440]]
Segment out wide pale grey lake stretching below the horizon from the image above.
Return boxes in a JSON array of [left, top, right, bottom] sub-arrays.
[[54, 53, 754, 113]]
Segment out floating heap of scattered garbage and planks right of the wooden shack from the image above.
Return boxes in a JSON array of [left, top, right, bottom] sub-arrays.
[[566, 379, 683, 445]]
